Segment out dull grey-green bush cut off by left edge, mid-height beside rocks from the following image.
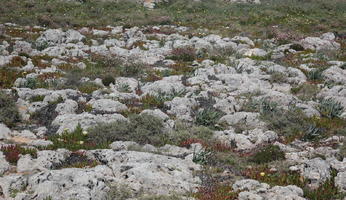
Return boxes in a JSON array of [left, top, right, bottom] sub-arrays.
[[0, 91, 20, 127]]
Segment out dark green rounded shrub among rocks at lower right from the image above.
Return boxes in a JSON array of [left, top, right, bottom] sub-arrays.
[[250, 145, 285, 164]]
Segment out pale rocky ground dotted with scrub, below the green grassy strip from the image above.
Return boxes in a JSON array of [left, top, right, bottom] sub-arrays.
[[0, 7, 346, 200]]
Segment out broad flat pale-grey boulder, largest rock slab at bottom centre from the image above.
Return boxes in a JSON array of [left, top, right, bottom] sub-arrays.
[[92, 150, 200, 195]]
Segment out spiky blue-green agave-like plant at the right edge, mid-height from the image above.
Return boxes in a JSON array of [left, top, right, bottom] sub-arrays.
[[317, 98, 344, 119]]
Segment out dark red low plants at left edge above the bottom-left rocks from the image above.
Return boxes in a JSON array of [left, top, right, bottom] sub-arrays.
[[0, 145, 37, 164]]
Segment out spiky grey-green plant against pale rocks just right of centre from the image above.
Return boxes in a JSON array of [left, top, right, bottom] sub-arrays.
[[196, 108, 224, 127]]
